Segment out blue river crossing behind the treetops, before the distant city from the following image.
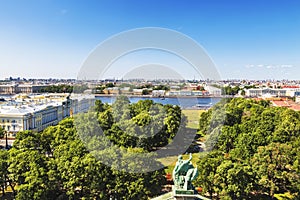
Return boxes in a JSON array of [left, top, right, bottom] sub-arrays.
[[96, 96, 221, 109]]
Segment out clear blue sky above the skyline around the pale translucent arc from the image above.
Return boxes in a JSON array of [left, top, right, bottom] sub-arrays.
[[0, 0, 300, 79]]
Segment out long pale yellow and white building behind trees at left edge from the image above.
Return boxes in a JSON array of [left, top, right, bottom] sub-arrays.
[[0, 94, 95, 142]]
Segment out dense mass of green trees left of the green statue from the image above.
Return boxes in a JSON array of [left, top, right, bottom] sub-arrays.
[[0, 97, 191, 199]]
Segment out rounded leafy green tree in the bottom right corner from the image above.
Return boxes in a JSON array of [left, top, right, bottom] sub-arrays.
[[252, 143, 300, 197]]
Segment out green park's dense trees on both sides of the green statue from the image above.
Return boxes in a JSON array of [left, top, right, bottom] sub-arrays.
[[0, 96, 300, 200]]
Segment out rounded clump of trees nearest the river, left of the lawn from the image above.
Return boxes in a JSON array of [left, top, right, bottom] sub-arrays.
[[98, 96, 185, 151]]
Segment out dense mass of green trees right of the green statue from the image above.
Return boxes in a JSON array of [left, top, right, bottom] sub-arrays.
[[197, 98, 300, 199]]
